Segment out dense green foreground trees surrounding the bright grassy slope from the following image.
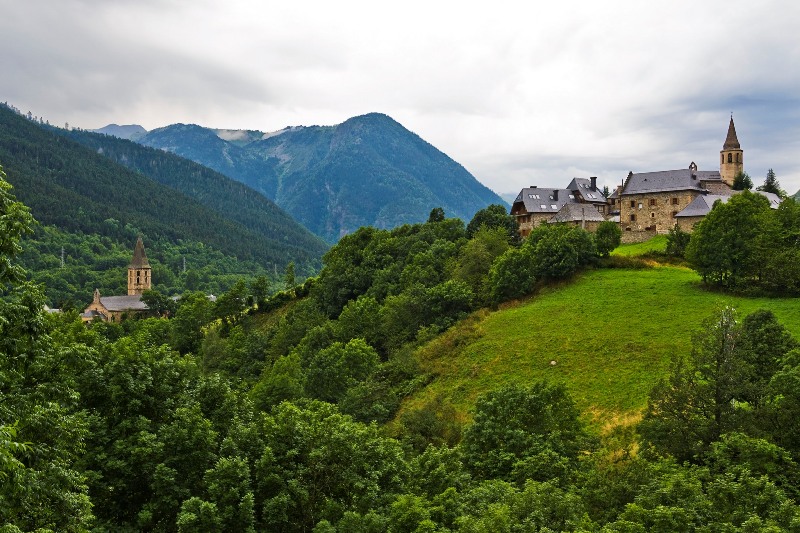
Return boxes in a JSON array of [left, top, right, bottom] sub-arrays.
[[0, 160, 800, 533]]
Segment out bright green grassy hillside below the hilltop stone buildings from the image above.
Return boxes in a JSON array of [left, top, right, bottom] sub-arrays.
[[404, 267, 800, 426]]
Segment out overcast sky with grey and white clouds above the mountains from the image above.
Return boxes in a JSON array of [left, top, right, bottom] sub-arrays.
[[0, 0, 800, 194]]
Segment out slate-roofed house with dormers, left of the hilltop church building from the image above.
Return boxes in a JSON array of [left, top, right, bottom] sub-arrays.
[[511, 177, 608, 237]]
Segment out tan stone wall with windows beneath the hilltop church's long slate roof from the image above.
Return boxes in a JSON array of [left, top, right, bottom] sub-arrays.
[[619, 190, 700, 234]]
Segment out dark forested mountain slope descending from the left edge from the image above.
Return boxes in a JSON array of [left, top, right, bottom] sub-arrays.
[[0, 106, 326, 274]]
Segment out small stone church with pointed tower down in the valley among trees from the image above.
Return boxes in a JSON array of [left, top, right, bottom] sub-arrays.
[[81, 237, 152, 322]]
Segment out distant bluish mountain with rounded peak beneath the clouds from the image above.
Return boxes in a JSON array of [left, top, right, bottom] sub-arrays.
[[137, 113, 503, 243]]
